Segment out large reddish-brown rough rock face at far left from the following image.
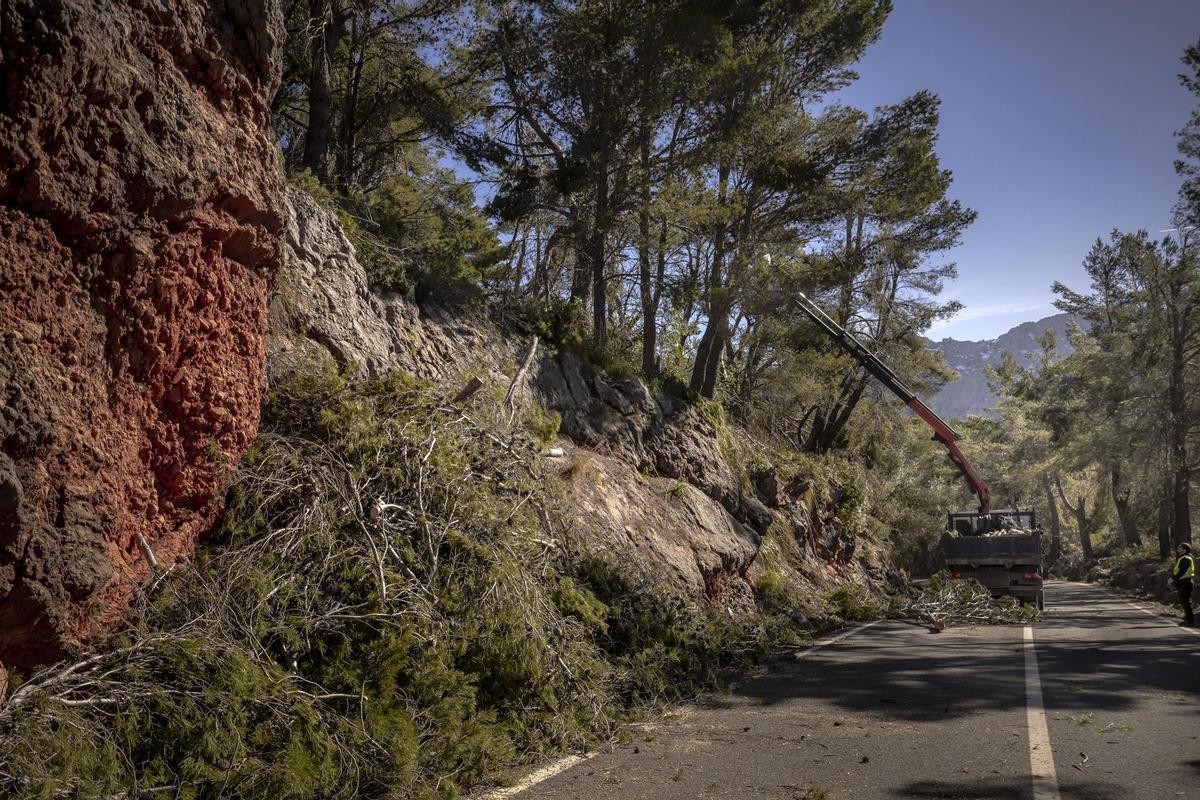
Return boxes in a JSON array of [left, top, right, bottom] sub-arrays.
[[0, 0, 283, 667]]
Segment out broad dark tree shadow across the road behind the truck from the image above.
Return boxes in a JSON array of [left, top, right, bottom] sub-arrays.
[[738, 588, 1200, 724]]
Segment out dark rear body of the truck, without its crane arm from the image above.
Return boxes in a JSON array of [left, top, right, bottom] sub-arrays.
[[942, 510, 1044, 609]]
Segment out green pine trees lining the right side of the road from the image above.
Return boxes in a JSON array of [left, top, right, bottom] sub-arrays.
[[969, 35, 1200, 560]]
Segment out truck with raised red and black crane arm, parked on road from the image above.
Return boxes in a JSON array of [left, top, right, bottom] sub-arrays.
[[797, 291, 1044, 609]]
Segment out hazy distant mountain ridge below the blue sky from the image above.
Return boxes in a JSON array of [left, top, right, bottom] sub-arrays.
[[929, 314, 1074, 420]]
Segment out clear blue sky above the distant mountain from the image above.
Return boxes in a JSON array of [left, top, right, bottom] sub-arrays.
[[839, 0, 1200, 339]]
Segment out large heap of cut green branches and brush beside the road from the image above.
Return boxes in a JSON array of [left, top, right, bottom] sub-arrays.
[[0, 365, 801, 800]]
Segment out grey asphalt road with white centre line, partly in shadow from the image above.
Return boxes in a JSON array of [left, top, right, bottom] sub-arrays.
[[497, 583, 1200, 800]]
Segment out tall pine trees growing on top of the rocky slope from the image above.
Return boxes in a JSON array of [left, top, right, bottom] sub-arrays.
[[276, 0, 974, 424]]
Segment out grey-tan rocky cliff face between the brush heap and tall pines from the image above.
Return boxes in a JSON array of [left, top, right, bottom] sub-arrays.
[[268, 190, 860, 612]]
